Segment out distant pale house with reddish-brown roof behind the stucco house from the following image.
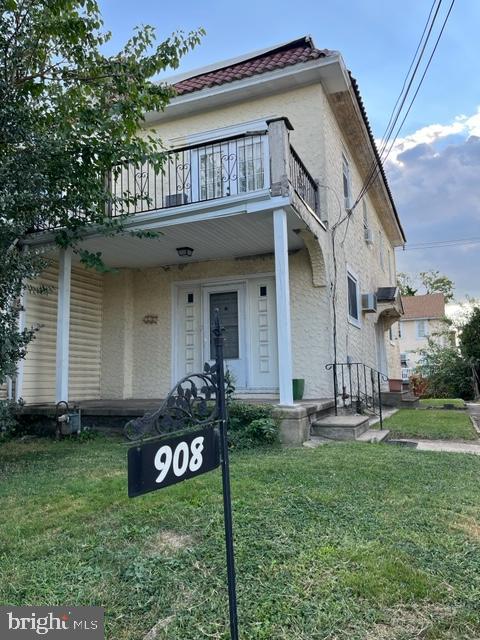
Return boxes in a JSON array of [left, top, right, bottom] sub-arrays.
[[396, 293, 451, 381]]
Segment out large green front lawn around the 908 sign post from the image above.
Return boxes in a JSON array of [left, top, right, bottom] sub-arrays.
[[0, 440, 480, 640]]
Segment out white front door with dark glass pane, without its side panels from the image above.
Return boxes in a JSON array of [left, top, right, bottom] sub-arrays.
[[203, 283, 247, 389]]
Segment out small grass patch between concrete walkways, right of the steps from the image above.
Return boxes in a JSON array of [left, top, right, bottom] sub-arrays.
[[383, 409, 478, 440]]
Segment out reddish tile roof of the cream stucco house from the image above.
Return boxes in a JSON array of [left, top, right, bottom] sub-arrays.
[[172, 36, 406, 242]]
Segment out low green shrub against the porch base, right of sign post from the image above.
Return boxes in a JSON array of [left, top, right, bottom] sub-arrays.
[[228, 401, 279, 449]]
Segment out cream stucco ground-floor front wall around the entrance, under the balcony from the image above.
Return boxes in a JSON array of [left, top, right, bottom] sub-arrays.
[[102, 249, 331, 398]]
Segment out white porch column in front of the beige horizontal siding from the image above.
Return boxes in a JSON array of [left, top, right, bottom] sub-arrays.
[[55, 248, 72, 402]]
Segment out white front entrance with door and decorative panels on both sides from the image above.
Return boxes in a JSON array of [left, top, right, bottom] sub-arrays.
[[172, 276, 278, 393]]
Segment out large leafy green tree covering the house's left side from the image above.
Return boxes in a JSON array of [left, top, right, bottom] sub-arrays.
[[0, 0, 203, 383]]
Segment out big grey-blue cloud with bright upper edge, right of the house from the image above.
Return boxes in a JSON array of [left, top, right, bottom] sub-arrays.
[[385, 109, 480, 297]]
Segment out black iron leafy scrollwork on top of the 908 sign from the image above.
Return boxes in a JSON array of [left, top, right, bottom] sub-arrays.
[[124, 363, 218, 440]]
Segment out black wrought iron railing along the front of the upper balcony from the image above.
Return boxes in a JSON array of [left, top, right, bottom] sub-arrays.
[[111, 134, 270, 216]]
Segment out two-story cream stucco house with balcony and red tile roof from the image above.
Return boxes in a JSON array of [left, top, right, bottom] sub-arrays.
[[12, 37, 405, 442]]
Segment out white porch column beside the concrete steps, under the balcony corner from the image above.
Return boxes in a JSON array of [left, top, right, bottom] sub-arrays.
[[273, 209, 293, 406]]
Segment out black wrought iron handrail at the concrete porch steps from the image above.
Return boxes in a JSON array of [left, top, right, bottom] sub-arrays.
[[325, 362, 388, 429]]
